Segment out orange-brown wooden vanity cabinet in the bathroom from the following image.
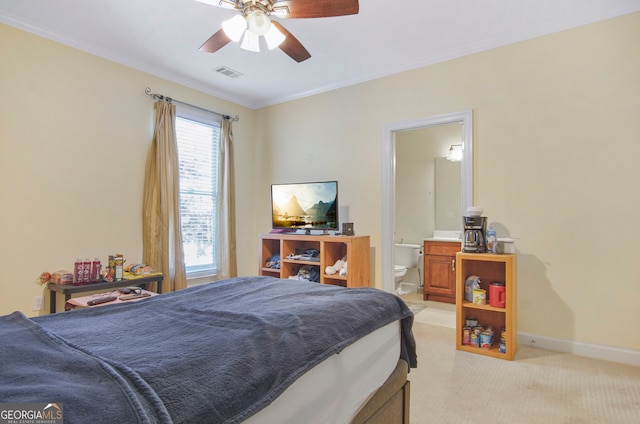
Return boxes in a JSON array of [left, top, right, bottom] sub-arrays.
[[423, 240, 460, 303]]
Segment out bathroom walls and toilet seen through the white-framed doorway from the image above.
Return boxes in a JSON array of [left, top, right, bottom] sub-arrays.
[[394, 122, 462, 293]]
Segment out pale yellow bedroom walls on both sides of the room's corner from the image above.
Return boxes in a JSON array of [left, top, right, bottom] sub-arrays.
[[0, 13, 640, 349]]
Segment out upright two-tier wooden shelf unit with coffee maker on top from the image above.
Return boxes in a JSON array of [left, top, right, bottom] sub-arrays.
[[456, 252, 518, 360]]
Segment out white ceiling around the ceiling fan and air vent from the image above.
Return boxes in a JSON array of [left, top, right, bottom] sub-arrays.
[[0, 0, 640, 109]]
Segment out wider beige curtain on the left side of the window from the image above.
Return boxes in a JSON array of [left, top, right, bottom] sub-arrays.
[[142, 101, 187, 293]]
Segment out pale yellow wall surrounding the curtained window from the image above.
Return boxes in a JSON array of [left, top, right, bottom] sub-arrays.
[[0, 25, 257, 315]]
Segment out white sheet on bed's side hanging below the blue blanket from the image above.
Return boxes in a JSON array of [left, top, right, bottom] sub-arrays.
[[245, 321, 400, 424]]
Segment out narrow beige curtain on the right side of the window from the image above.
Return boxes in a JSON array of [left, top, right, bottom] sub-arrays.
[[216, 119, 238, 280]]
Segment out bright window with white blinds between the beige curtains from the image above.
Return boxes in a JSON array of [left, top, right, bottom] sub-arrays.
[[176, 105, 220, 278]]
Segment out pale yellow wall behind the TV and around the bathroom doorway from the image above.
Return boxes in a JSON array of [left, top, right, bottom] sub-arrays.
[[257, 13, 640, 349]]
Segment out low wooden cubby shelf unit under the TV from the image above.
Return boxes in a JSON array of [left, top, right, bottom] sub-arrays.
[[259, 233, 370, 287]]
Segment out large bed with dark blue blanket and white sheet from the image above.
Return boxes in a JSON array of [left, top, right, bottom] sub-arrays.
[[0, 277, 417, 424]]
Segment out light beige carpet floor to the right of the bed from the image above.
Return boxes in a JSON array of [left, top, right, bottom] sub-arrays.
[[409, 322, 640, 424]]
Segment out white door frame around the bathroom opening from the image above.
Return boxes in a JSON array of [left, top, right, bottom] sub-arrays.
[[381, 110, 473, 292]]
